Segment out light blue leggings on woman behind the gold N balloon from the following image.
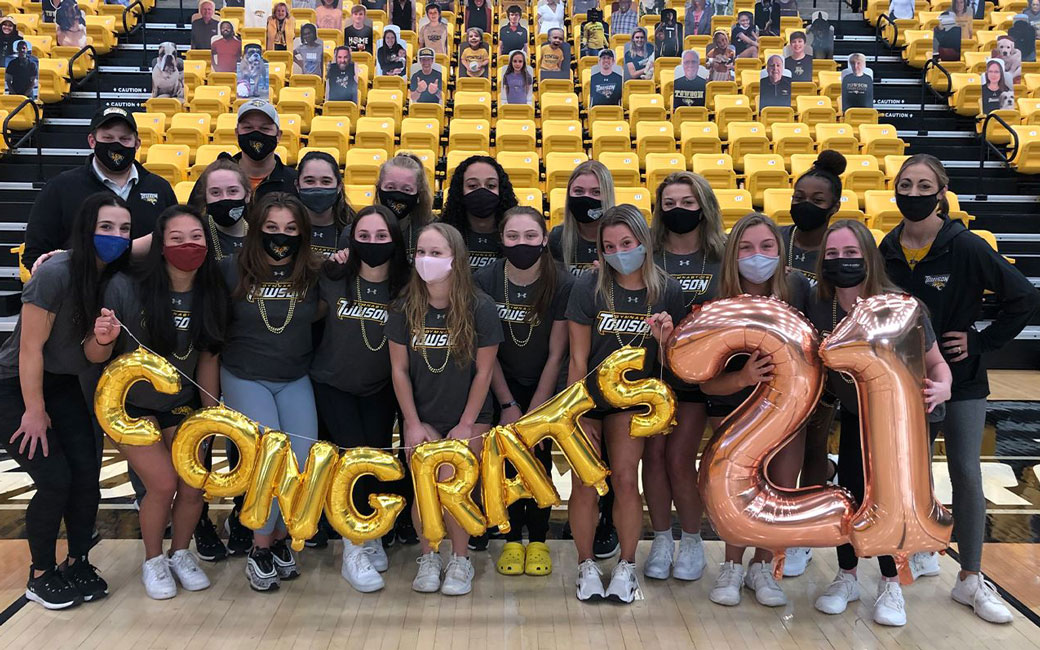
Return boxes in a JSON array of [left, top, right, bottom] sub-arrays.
[[220, 368, 318, 535]]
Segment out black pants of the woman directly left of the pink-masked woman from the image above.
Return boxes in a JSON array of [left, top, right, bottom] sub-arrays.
[[313, 382, 397, 514]]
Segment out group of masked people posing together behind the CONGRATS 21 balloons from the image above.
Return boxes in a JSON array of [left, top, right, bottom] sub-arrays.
[[0, 100, 1040, 625]]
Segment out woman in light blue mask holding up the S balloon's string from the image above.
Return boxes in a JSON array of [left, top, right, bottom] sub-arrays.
[[567, 204, 685, 603]]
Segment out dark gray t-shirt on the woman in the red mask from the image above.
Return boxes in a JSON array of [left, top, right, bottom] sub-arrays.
[[102, 274, 199, 411]]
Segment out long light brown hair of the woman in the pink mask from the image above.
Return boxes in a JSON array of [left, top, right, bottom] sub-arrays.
[[401, 222, 476, 366]]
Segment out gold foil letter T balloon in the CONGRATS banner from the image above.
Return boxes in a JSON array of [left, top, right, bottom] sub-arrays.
[[512, 382, 610, 496]]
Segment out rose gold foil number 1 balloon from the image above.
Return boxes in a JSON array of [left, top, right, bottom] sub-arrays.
[[820, 293, 953, 556]]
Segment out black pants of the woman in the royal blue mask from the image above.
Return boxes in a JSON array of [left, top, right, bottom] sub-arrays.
[[0, 372, 101, 571]]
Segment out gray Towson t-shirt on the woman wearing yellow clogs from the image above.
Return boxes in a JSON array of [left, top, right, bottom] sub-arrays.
[[473, 255, 574, 386]]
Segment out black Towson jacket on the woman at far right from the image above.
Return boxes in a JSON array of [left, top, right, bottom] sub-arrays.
[[881, 218, 1040, 401]]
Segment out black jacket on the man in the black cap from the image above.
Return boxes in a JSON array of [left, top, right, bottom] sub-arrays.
[[22, 155, 177, 268]]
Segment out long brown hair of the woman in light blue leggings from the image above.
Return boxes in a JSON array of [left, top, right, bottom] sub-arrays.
[[232, 191, 321, 300]]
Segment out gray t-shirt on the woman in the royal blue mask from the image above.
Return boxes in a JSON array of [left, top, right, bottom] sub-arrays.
[[0, 253, 94, 379]]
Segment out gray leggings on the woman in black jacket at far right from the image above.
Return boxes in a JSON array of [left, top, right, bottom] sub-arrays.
[[933, 399, 986, 571]]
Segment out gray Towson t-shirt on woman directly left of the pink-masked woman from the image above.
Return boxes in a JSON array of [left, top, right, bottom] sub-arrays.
[[311, 275, 390, 395]]
